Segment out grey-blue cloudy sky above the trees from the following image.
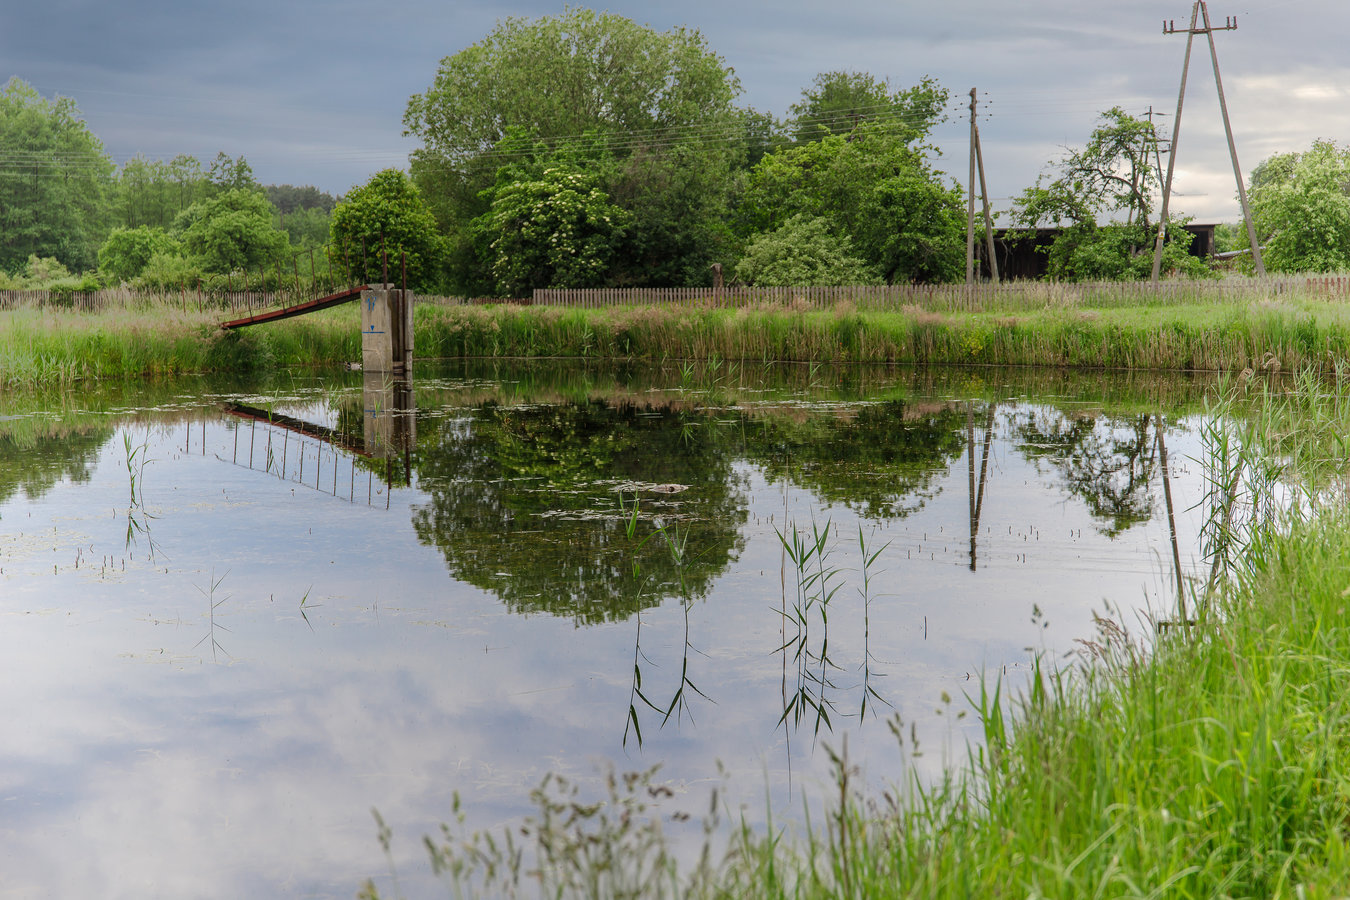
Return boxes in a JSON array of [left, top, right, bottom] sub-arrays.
[[0, 0, 1350, 221]]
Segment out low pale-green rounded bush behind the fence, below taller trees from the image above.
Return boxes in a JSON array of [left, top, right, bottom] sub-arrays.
[[736, 215, 882, 286]]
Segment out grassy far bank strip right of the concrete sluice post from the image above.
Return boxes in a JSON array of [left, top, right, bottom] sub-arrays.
[[417, 301, 1350, 371]]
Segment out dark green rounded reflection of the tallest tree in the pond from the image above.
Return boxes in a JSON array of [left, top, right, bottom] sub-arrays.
[[413, 399, 747, 625]]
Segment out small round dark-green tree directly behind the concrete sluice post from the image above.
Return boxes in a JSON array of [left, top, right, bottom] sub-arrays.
[[331, 169, 444, 290]]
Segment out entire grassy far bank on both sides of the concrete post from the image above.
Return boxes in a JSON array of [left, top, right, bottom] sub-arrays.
[[13, 294, 1350, 385]]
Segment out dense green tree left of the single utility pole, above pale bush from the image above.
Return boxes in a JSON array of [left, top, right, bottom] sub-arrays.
[[737, 123, 965, 283]]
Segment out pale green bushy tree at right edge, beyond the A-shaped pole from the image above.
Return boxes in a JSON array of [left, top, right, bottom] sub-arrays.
[[1250, 140, 1350, 273]]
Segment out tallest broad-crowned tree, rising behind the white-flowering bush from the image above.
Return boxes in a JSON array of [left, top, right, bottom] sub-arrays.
[[404, 8, 752, 291]]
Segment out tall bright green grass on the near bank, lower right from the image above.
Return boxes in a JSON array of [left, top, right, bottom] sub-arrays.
[[365, 376, 1350, 900]]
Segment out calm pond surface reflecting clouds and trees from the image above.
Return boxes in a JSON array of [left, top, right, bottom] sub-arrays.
[[0, 366, 1220, 897]]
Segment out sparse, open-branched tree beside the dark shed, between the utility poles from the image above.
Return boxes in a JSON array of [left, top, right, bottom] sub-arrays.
[[1011, 107, 1207, 281]]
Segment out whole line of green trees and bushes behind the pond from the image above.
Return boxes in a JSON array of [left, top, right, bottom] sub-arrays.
[[0, 8, 1350, 297]]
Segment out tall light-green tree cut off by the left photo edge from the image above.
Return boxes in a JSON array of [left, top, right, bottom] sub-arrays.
[[0, 78, 115, 273]]
